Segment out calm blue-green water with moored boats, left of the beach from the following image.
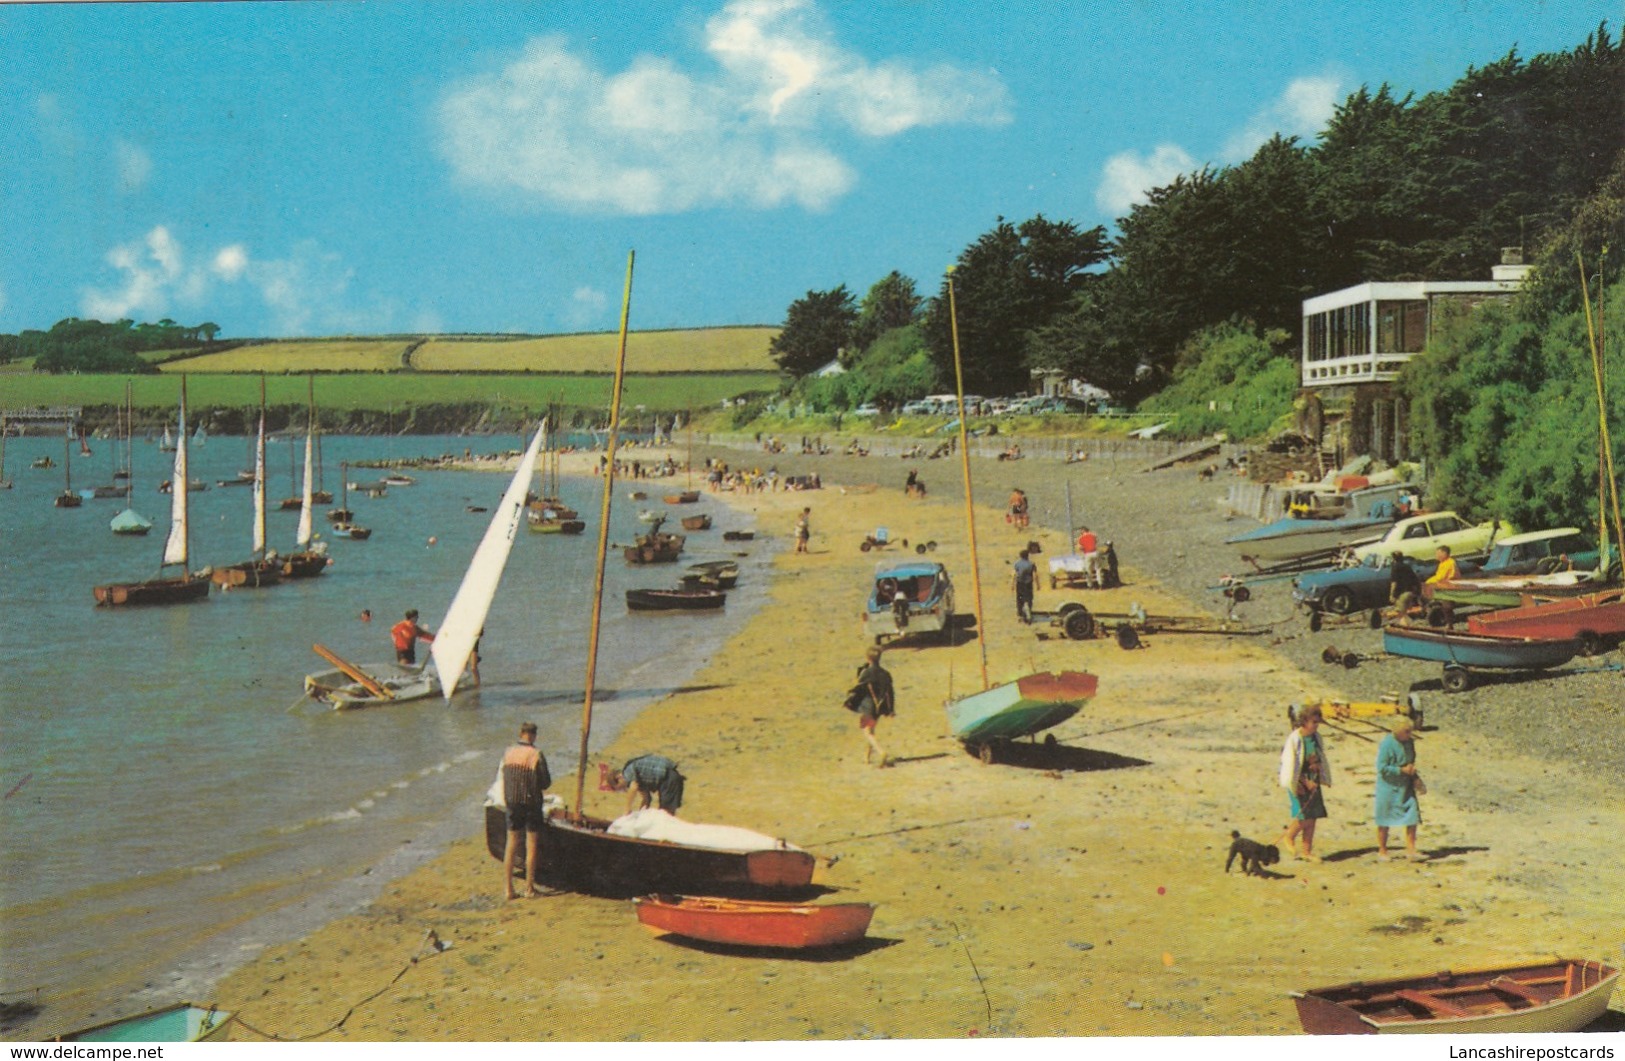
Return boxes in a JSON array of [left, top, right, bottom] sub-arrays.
[[0, 437, 767, 1007]]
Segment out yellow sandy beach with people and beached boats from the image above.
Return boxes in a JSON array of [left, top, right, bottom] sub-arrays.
[[203, 441, 1625, 1042]]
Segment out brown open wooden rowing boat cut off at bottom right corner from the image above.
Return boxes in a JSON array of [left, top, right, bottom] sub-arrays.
[[1292, 959, 1620, 1035]]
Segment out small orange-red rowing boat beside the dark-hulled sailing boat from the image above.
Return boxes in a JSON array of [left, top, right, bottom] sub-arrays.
[[634, 895, 874, 951]]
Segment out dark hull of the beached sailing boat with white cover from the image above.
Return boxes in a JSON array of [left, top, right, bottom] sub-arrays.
[[486, 804, 816, 897]]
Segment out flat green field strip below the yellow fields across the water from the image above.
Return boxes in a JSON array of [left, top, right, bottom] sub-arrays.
[[0, 372, 778, 414]]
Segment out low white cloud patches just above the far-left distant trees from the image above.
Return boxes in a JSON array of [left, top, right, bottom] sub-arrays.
[[80, 224, 377, 335]]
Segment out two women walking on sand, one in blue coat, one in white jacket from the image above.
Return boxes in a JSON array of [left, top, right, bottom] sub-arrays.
[[1277, 705, 1427, 863]]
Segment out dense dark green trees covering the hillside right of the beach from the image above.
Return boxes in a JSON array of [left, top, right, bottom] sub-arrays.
[[770, 24, 1625, 408]]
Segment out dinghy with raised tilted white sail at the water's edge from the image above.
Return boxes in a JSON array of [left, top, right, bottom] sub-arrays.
[[306, 421, 548, 708]]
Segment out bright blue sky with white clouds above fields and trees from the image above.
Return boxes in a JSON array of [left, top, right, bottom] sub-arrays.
[[0, 0, 1619, 338]]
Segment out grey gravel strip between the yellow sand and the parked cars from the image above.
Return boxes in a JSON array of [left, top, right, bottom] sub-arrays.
[[696, 447, 1625, 780]]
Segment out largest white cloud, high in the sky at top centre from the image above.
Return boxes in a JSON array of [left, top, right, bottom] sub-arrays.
[[437, 0, 1009, 214]]
